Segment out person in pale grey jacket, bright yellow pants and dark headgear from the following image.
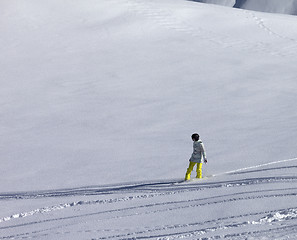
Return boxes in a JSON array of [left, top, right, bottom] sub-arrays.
[[185, 133, 207, 180]]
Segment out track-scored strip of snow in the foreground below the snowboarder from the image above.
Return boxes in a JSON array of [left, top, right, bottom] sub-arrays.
[[0, 159, 297, 240]]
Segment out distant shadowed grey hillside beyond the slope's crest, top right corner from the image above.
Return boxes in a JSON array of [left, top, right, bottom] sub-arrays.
[[195, 0, 297, 15]]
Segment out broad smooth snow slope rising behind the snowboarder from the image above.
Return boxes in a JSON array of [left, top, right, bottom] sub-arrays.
[[0, 0, 297, 192]]
